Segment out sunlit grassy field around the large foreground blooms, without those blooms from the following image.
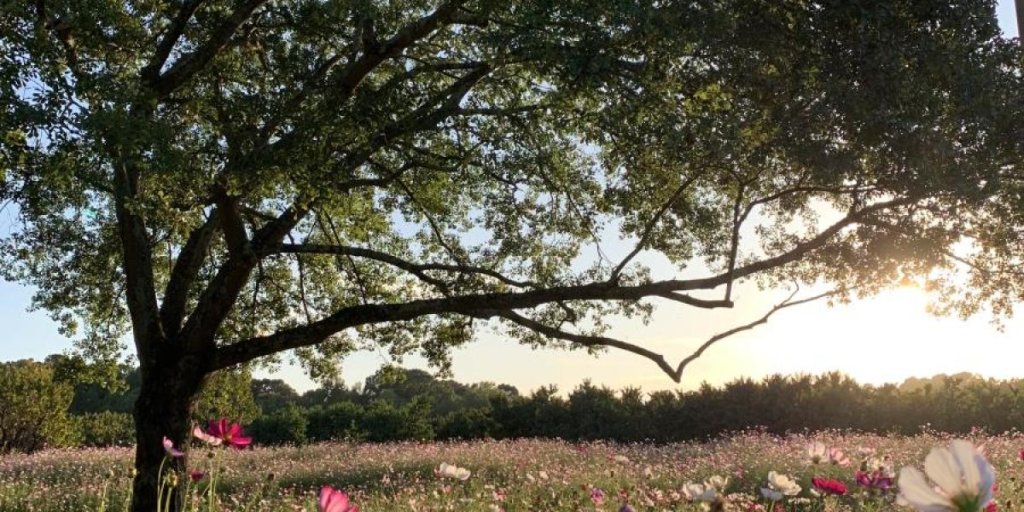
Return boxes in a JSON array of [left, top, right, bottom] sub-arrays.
[[0, 432, 1024, 512]]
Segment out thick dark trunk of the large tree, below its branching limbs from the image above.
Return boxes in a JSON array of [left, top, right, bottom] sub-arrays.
[[131, 365, 203, 512]]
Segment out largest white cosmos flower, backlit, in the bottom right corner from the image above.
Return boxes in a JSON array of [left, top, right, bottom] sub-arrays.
[[898, 439, 995, 512]]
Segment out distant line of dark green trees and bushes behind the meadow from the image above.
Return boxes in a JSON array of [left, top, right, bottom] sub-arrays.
[[0, 358, 1024, 452]]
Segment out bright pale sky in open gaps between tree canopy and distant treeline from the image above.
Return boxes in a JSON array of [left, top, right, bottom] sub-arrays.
[[0, 4, 1024, 392]]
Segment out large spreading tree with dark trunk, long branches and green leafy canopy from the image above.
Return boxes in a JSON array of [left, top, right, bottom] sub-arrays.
[[0, 0, 1024, 512]]
